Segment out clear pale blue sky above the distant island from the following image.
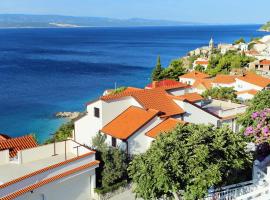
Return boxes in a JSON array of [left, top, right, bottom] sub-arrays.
[[0, 0, 270, 24]]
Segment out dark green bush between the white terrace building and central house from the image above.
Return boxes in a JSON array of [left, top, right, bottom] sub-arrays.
[[92, 133, 128, 194]]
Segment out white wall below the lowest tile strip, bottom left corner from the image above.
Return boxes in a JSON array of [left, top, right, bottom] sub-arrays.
[[16, 170, 95, 200]]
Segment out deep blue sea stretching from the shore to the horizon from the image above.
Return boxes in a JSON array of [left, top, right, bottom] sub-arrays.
[[0, 25, 266, 142]]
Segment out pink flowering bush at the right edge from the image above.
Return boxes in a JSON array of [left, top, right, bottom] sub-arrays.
[[244, 108, 270, 144]]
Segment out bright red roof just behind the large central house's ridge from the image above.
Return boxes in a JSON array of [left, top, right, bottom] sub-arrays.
[[145, 79, 189, 90]]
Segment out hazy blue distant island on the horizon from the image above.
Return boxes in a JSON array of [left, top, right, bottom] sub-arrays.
[[0, 14, 199, 28]]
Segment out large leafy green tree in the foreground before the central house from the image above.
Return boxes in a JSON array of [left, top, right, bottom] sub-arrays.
[[128, 124, 252, 200]]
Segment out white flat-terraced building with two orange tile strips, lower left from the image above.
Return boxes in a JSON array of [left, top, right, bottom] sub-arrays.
[[0, 139, 99, 200]]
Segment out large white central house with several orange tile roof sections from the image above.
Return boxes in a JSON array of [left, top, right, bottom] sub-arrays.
[[73, 85, 247, 154]]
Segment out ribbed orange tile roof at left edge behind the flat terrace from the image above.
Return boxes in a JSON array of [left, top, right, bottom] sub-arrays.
[[0, 135, 38, 158]]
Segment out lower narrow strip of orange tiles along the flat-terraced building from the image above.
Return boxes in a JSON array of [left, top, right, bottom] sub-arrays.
[[1, 160, 100, 200]]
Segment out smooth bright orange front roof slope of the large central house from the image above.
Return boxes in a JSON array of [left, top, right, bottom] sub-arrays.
[[101, 106, 159, 140]]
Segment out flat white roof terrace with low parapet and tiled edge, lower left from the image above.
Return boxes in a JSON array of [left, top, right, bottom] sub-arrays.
[[0, 140, 97, 198]]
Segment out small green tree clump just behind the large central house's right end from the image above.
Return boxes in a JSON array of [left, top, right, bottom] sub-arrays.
[[202, 87, 238, 102]]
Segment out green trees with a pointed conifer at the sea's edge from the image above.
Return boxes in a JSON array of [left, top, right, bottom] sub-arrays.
[[152, 57, 186, 81]]
